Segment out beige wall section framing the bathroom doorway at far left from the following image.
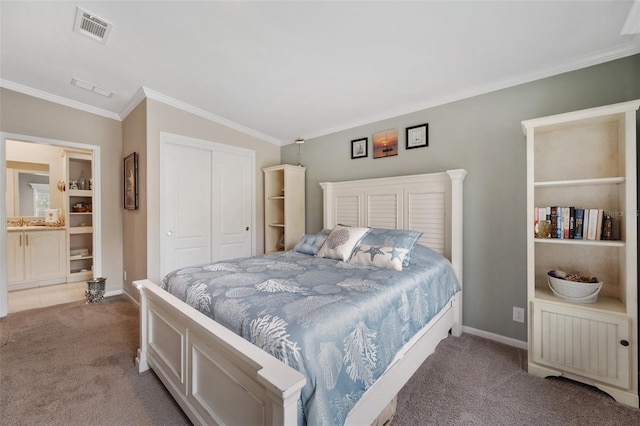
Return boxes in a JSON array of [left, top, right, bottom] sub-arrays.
[[0, 88, 123, 292]]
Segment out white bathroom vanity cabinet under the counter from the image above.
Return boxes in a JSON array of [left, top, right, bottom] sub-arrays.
[[7, 229, 67, 290]]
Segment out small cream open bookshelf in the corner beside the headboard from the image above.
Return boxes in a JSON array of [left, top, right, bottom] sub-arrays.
[[262, 164, 306, 253]]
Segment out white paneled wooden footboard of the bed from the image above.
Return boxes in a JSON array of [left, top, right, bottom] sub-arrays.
[[134, 280, 306, 425]]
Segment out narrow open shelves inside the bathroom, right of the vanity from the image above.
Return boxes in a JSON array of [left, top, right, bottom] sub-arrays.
[[65, 152, 93, 282]]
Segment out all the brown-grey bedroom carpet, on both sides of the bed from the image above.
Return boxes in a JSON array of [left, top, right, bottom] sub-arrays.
[[0, 296, 640, 426]]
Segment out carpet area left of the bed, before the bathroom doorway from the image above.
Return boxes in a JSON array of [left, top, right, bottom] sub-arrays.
[[0, 296, 191, 426]]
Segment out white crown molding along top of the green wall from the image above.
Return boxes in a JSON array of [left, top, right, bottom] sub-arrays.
[[302, 37, 640, 143]]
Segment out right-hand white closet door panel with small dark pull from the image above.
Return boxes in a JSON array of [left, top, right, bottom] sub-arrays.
[[212, 151, 253, 261]]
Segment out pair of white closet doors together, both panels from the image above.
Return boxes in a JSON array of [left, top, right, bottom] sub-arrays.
[[160, 134, 255, 276]]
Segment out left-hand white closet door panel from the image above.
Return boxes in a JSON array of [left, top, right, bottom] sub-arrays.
[[160, 141, 212, 276]]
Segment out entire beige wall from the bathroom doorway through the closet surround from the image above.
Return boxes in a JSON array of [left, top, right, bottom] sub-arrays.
[[0, 88, 280, 299]]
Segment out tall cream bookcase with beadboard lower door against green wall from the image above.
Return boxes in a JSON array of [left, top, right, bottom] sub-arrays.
[[522, 100, 640, 407]]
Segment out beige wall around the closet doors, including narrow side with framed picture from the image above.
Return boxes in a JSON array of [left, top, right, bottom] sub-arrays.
[[123, 99, 280, 297]]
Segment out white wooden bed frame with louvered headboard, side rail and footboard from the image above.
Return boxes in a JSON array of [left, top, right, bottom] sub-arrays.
[[134, 170, 467, 426]]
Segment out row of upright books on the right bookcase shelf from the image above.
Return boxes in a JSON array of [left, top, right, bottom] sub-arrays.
[[533, 206, 613, 240]]
